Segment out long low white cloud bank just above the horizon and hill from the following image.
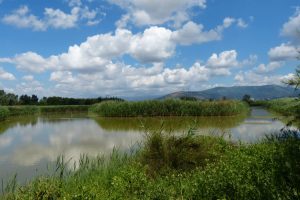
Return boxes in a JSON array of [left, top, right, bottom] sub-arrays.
[[45, 50, 244, 96]]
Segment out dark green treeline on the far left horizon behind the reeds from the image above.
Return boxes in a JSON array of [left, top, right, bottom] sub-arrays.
[[0, 90, 124, 106]]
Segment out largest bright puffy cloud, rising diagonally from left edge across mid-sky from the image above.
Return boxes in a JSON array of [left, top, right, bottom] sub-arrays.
[[0, 18, 236, 73]]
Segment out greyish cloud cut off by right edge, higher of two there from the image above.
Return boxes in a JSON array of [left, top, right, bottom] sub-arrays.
[[281, 8, 300, 41]]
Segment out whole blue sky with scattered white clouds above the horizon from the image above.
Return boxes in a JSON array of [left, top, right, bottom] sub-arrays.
[[0, 0, 300, 98]]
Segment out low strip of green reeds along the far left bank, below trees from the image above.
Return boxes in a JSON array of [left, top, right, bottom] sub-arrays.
[[0, 105, 89, 121]]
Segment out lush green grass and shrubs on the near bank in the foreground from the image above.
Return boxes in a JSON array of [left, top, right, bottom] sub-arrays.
[[2, 130, 300, 199]]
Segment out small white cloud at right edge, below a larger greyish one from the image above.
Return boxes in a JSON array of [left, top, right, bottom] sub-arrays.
[[268, 43, 300, 61]]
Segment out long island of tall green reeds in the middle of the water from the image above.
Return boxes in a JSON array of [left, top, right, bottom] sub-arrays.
[[91, 99, 248, 117]]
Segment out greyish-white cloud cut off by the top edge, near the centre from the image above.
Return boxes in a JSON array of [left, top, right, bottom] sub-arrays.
[[109, 0, 206, 26]]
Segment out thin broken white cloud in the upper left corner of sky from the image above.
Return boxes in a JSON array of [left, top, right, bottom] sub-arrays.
[[1, 3, 100, 31]]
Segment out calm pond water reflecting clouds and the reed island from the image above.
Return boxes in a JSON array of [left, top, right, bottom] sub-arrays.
[[0, 108, 296, 182]]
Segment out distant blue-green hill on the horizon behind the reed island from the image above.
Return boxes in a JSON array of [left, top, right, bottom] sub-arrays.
[[160, 85, 300, 100]]
